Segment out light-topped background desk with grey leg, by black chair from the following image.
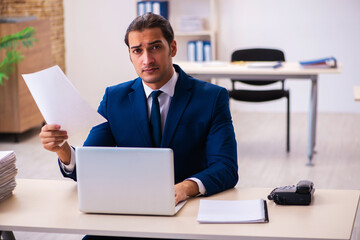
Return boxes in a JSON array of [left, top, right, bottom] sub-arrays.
[[176, 62, 341, 165]]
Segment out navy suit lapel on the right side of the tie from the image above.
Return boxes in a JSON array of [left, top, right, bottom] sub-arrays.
[[161, 69, 192, 147]]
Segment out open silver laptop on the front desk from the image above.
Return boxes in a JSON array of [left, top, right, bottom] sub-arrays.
[[75, 147, 185, 215]]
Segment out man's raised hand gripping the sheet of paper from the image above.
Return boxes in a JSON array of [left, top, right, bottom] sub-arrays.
[[39, 124, 71, 165]]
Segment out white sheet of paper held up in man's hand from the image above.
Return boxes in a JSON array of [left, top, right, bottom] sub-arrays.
[[22, 66, 106, 136]]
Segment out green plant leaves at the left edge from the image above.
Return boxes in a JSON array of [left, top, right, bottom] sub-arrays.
[[0, 27, 37, 85]]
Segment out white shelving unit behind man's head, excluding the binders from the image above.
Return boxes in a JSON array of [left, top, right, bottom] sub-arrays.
[[136, 0, 218, 62]]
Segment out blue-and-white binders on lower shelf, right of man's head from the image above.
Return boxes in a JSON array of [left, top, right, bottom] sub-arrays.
[[187, 40, 211, 62]]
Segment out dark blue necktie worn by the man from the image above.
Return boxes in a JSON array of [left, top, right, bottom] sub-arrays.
[[150, 90, 162, 147]]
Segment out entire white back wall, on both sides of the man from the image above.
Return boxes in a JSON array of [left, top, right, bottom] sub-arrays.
[[64, 0, 360, 113]]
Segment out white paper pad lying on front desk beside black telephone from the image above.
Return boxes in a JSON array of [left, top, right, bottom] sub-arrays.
[[197, 199, 269, 223]]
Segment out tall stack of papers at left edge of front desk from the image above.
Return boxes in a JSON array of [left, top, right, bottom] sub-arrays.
[[0, 151, 17, 201]]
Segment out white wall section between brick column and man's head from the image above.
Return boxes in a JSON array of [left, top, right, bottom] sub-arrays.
[[64, 0, 137, 109]]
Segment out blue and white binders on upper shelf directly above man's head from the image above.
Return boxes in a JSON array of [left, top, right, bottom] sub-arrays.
[[137, 1, 169, 19]]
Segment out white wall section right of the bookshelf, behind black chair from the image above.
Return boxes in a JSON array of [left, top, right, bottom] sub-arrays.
[[218, 0, 360, 113]]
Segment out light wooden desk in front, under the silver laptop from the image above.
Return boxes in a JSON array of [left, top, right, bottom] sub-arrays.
[[0, 179, 360, 239]]
